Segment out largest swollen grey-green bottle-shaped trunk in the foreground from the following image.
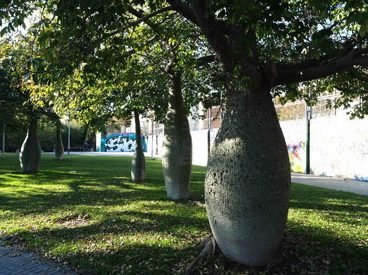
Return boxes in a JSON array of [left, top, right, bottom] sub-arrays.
[[205, 89, 290, 266]]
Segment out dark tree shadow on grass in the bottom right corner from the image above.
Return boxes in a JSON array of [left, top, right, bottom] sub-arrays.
[[284, 221, 368, 274]]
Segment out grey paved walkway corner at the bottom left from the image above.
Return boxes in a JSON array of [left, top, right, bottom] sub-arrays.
[[0, 240, 76, 275]]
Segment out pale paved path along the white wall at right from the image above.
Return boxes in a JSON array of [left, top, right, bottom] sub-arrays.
[[291, 173, 368, 196]]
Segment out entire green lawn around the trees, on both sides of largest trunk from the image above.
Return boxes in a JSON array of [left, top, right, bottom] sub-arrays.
[[0, 154, 368, 274]]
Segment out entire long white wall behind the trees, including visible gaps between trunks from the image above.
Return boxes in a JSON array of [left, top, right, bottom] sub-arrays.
[[99, 103, 368, 181]]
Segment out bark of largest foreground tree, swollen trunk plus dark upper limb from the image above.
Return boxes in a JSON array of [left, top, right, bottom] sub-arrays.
[[167, 0, 290, 266]]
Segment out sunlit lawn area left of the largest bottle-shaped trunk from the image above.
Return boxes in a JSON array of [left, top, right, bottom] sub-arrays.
[[0, 155, 210, 274]]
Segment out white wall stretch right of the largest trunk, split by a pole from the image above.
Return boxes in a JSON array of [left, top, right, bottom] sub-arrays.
[[280, 112, 368, 180]]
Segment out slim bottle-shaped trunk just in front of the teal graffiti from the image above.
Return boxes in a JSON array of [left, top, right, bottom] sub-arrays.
[[131, 111, 146, 182]]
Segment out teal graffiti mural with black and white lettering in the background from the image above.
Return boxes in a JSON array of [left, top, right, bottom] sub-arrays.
[[101, 133, 147, 152]]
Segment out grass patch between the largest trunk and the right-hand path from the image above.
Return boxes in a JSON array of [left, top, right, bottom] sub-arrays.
[[288, 184, 368, 274]]
